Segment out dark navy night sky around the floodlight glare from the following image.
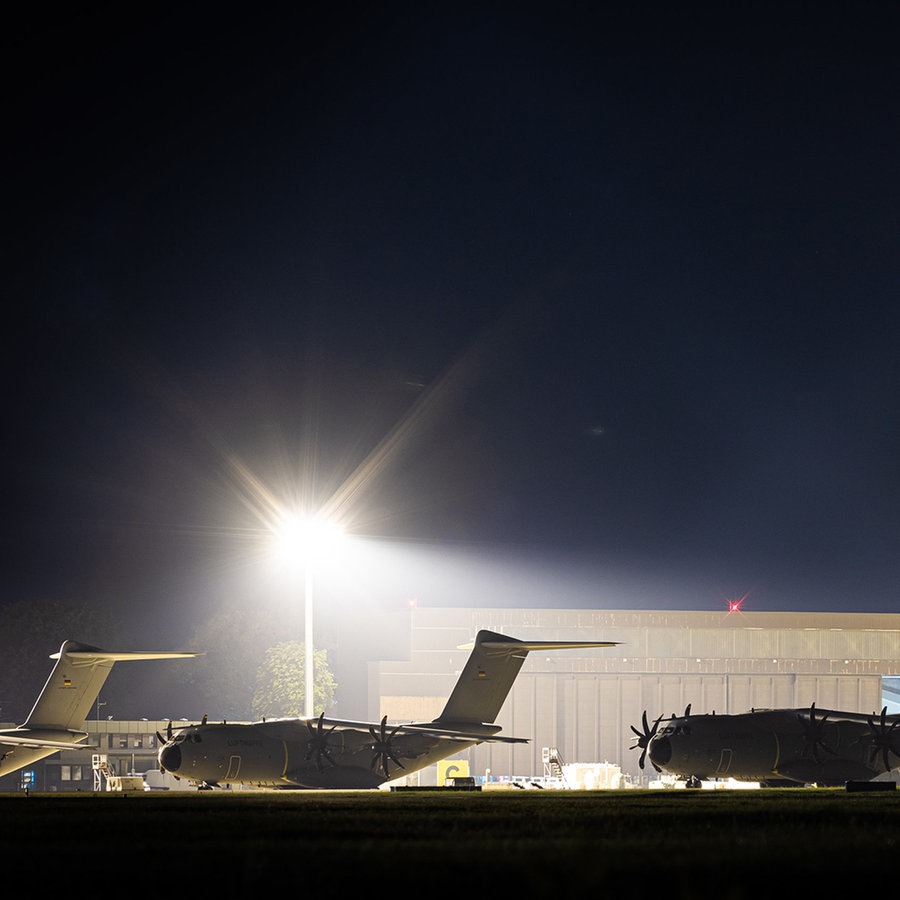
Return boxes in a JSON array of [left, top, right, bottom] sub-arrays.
[[0, 2, 900, 643]]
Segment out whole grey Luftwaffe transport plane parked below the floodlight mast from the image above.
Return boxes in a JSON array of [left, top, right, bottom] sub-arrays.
[[158, 630, 618, 790]]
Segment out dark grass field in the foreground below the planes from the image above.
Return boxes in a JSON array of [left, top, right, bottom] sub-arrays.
[[0, 788, 900, 888]]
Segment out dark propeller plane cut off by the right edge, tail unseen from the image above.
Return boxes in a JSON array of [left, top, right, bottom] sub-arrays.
[[631, 703, 900, 787]]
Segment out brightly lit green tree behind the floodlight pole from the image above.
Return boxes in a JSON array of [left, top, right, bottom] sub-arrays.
[[252, 641, 336, 719]]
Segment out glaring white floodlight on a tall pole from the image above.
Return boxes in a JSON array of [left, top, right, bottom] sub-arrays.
[[275, 514, 343, 719]]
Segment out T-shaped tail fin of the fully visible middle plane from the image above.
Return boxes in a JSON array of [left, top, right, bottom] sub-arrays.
[[435, 630, 618, 725]]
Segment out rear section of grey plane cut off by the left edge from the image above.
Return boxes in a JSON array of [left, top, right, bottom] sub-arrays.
[[0, 641, 198, 775]]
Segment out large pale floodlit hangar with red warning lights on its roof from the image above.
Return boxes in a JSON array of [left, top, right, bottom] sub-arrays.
[[368, 608, 900, 784]]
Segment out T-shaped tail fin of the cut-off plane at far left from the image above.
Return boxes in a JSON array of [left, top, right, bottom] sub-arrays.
[[22, 641, 197, 731]]
